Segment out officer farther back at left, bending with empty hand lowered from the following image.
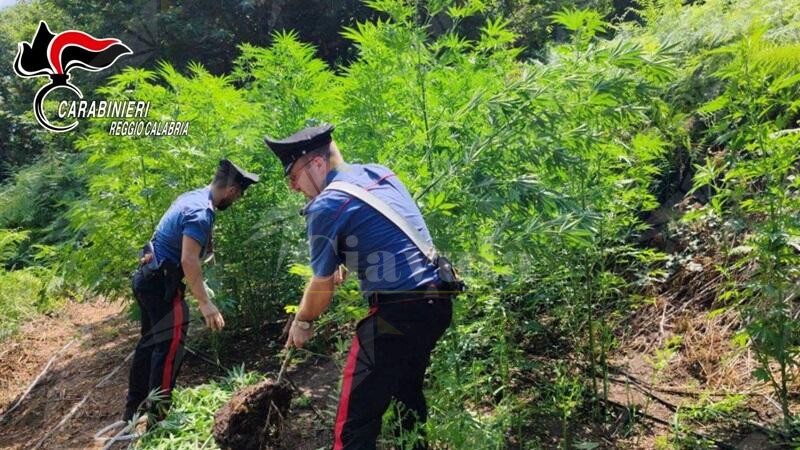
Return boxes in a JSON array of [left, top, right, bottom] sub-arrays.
[[123, 159, 258, 421]]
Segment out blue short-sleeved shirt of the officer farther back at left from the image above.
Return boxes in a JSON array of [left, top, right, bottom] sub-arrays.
[[153, 187, 214, 264]]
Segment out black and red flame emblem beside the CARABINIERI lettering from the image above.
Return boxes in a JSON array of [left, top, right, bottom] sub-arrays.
[[14, 21, 133, 132]]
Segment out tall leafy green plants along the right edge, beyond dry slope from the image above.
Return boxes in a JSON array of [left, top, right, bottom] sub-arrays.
[[696, 28, 800, 427]]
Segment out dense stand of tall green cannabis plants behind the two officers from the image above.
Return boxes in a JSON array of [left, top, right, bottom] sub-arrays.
[[62, 1, 672, 447]]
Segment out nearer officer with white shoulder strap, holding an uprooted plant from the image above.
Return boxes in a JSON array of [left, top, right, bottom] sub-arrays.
[[265, 125, 452, 450]]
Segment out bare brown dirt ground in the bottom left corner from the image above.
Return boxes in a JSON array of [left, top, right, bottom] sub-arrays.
[[0, 300, 138, 449]]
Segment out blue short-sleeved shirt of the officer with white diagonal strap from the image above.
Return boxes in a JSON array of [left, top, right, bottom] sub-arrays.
[[305, 164, 439, 294]]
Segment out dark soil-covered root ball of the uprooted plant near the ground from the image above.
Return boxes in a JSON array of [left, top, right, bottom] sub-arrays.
[[214, 380, 292, 450]]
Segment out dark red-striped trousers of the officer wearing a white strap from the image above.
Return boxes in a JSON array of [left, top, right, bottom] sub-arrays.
[[333, 298, 453, 450]]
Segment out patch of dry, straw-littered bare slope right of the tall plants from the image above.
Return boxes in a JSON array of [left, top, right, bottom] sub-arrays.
[[609, 259, 800, 450]]
